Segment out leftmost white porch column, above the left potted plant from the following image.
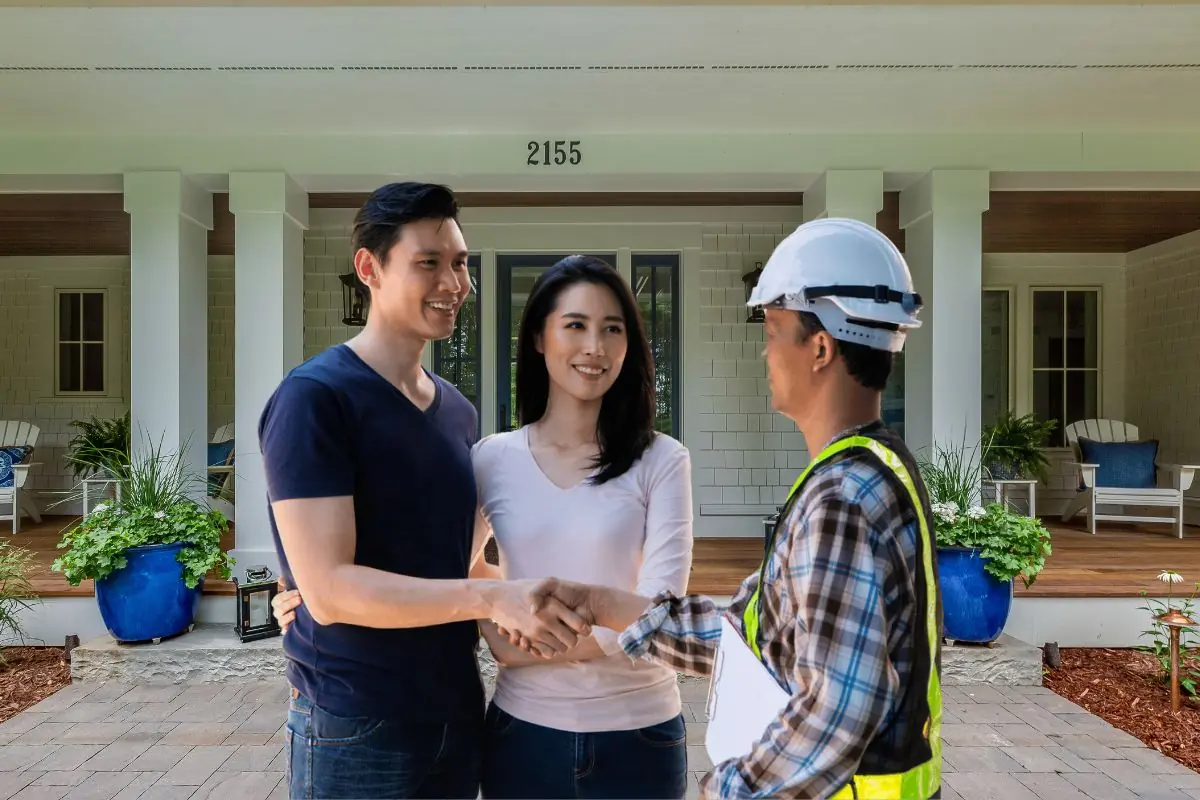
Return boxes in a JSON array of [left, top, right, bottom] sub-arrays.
[[125, 172, 212, 489]]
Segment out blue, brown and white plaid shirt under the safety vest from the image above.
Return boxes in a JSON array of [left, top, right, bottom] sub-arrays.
[[620, 432, 925, 798]]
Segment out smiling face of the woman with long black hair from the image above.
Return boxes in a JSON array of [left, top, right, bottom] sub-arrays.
[[538, 282, 629, 402]]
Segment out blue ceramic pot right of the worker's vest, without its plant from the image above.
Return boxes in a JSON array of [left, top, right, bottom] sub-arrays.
[[937, 547, 1013, 644]]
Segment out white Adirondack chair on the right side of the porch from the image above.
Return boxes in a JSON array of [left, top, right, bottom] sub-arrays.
[[1062, 420, 1200, 539]]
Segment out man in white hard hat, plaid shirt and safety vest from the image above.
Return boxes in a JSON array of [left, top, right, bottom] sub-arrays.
[[520, 218, 942, 800]]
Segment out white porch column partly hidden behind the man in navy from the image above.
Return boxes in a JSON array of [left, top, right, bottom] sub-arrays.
[[229, 173, 308, 576]]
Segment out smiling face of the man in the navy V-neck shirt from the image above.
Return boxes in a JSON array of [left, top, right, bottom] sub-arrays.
[[354, 219, 470, 342]]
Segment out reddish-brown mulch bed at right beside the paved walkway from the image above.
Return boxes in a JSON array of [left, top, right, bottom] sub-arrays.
[[1045, 648, 1200, 771]]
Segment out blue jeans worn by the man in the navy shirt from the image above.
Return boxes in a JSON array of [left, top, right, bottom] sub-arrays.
[[287, 691, 484, 800]]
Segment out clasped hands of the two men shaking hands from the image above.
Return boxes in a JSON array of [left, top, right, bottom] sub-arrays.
[[490, 578, 611, 658]]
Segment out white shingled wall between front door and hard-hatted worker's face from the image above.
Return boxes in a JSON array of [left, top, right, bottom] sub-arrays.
[[684, 218, 809, 516]]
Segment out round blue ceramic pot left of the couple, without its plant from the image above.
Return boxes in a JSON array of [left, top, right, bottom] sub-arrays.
[[96, 543, 204, 642]]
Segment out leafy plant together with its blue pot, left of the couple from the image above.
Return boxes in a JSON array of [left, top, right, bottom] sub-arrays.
[[53, 431, 233, 642]]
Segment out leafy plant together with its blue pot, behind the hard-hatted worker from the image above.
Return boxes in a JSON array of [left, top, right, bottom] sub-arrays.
[[920, 434, 1050, 644]]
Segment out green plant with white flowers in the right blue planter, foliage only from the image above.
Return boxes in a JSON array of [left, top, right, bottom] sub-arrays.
[[920, 438, 1051, 587]]
